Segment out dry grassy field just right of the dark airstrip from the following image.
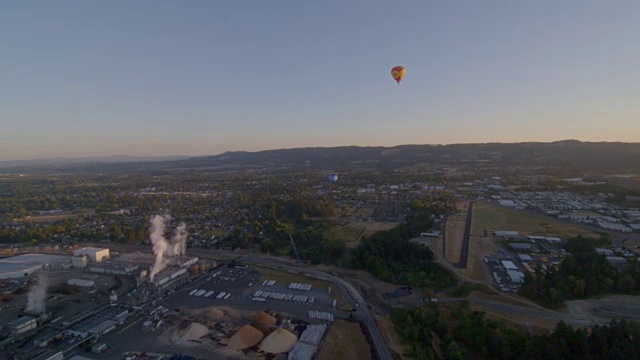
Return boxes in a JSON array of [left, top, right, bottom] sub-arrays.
[[471, 202, 600, 239]]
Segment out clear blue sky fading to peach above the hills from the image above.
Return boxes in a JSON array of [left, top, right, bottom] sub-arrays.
[[0, 0, 640, 160]]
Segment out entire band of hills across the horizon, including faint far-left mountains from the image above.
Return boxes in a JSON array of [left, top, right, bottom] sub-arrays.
[[0, 140, 640, 172]]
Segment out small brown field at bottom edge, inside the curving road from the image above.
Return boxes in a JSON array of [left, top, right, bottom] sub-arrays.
[[318, 320, 371, 360]]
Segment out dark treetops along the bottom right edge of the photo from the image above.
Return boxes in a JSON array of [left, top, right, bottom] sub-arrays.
[[392, 304, 640, 360]]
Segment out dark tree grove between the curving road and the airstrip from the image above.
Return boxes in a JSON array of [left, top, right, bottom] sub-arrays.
[[351, 200, 455, 288]]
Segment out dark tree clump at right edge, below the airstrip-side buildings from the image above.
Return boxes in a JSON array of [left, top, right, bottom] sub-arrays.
[[520, 237, 640, 308]]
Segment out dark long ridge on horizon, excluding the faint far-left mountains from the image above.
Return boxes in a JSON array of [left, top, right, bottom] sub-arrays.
[[175, 140, 640, 169]]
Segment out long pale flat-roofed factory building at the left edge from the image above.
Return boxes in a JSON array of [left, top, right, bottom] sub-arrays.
[[0, 254, 71, 279]]
